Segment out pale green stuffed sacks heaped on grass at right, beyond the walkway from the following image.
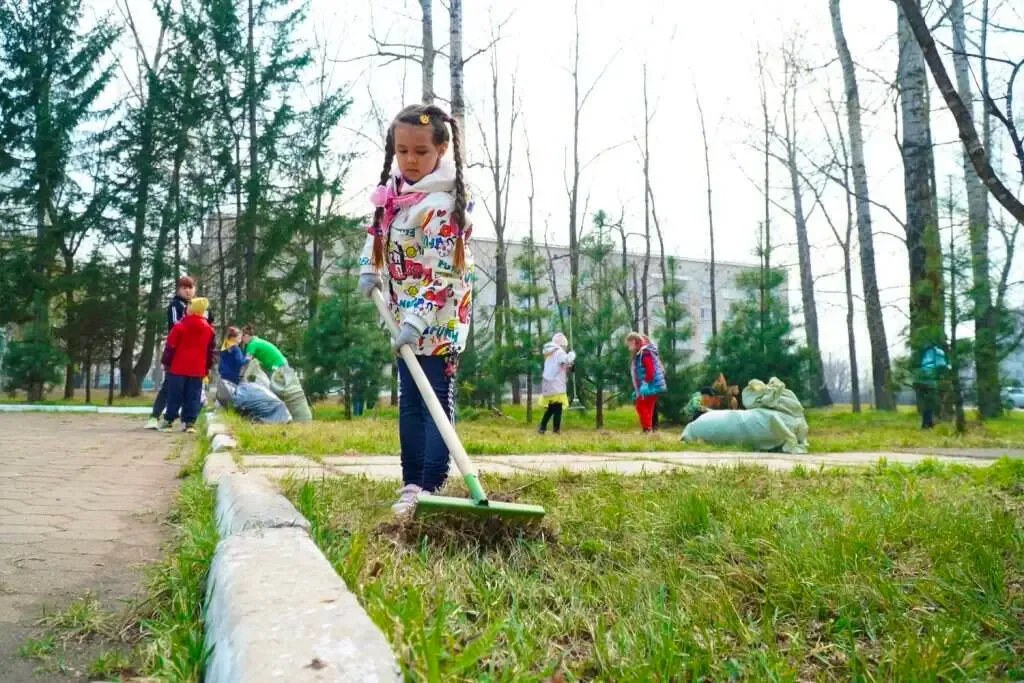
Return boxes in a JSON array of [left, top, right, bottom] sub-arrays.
[[683, 377, 808, 454]]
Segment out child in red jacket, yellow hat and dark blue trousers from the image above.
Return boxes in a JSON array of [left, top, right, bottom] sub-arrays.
[[160, 298, 215, 433]]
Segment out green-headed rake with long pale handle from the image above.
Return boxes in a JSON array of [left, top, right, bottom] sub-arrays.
[[373, 289, 545, 519]]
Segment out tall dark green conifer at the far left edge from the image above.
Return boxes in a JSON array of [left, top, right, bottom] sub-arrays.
[[0, 0, 118, 400]]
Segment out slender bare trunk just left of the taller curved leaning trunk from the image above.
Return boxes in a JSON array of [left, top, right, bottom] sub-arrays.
[[782, 53, 833, 407]]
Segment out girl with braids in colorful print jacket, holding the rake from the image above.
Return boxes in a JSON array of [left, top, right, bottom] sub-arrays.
[[359, 104, 473, 514]]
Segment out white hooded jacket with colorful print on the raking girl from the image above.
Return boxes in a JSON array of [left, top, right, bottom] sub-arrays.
[[359, 159, 473, 355]]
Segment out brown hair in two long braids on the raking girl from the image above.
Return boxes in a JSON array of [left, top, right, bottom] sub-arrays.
[[373, 104, 466, 272]]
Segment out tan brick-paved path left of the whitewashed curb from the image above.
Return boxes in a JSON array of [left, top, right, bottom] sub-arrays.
[[0, 414, 181, 683]]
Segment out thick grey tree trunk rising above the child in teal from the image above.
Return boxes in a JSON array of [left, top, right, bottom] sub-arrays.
[[897, 0, 945, 404]]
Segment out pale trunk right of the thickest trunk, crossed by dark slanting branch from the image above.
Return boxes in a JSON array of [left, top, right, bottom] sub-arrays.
[[949, 0, 1002, 418]]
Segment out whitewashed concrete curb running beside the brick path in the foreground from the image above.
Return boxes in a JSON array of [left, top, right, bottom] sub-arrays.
[[203, 423, 402, 683]]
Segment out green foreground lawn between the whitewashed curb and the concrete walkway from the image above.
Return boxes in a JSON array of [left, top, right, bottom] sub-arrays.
[[287, 459, 1024, 682]]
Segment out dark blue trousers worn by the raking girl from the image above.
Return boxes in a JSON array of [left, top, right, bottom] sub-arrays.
[[398, 355, 455, 492]]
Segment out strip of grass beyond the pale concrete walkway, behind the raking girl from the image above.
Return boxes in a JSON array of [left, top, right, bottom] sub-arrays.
[[226, 403, 1024, 457]]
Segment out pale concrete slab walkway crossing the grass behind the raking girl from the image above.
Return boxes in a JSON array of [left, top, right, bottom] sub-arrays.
[[224, 450, 1007, 479]]
